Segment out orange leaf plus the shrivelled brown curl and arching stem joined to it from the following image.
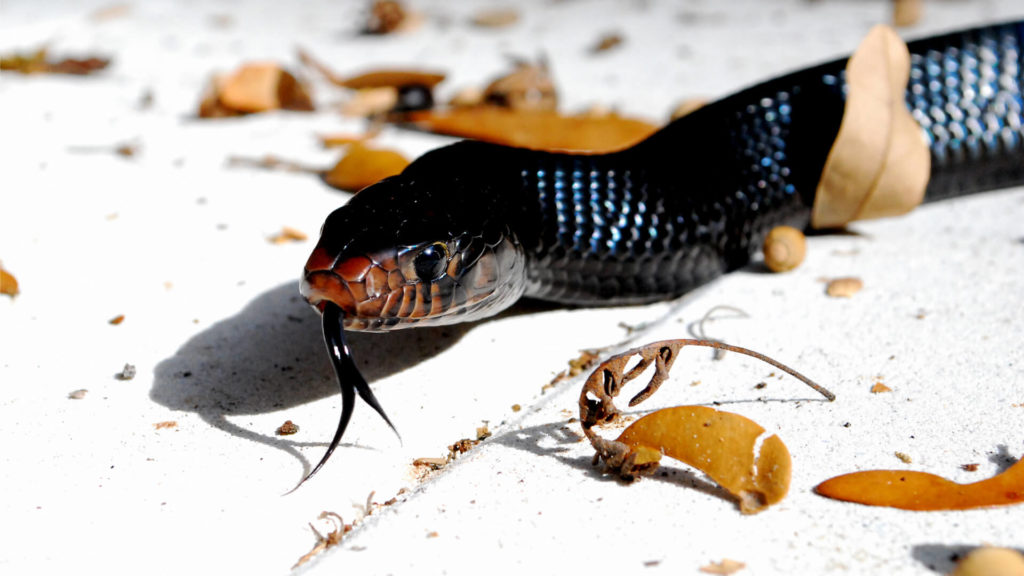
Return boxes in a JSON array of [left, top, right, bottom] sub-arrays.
[[580, 339, 836, 513]]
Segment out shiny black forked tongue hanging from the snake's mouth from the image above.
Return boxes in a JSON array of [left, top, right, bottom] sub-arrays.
[[292, 302, 401, 490]]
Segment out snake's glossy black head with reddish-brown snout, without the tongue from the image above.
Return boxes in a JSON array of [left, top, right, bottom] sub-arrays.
[[300, 145, 525, 330]]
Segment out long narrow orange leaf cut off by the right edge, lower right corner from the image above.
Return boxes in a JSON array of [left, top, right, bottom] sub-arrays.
[[814, 453, 1024, 510]]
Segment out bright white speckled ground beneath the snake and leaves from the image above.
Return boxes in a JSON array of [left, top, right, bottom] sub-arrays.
[[0, 0, 1024, 574]]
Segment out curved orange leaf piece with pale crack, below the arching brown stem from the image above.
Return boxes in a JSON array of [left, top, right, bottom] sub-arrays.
[[617, 406, 793, 513]]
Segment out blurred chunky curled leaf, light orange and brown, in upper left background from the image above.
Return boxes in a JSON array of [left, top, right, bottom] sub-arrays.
[[199, 63, 313, 118]]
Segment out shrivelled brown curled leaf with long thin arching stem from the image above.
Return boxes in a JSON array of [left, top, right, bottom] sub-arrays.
[[580, 338, 836, 477]]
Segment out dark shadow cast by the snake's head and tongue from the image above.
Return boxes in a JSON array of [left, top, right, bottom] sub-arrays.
[[150, 282, 550, 466]]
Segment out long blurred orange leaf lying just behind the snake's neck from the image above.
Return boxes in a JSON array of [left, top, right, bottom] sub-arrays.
[[409, 106, 657, 154]]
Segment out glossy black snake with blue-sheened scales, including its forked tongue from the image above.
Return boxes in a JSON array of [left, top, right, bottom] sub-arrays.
[[292, 20, 1024, 484]]
